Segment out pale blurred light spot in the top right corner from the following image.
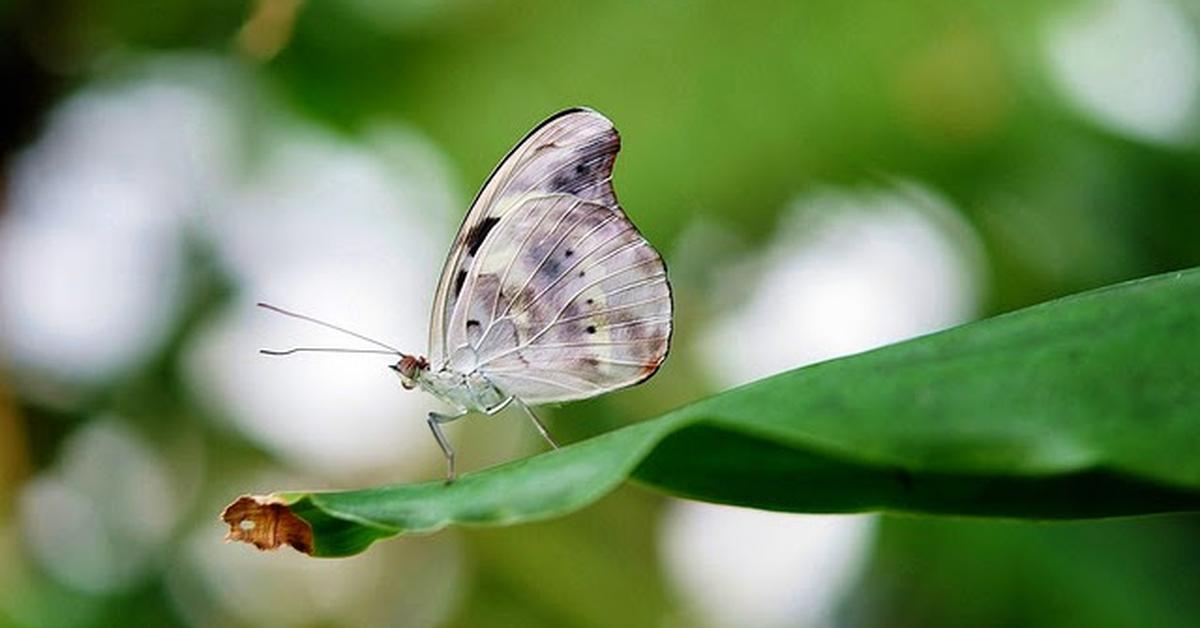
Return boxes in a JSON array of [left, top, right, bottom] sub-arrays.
[[1044, 0, 1200, 144]]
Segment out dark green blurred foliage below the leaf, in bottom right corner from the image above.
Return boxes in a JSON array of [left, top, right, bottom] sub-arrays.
[[844, 516, 1200, 628]]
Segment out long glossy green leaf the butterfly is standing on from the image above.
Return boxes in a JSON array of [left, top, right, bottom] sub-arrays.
[[224, 269, 1200, 556]]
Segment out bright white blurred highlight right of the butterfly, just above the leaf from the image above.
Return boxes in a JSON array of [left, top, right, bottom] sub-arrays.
[[702, 184, 982, 385]]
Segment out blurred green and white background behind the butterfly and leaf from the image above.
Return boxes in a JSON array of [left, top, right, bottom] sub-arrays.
[[0, 0, 1200, 628]]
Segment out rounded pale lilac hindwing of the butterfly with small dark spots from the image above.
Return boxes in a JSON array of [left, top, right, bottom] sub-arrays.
[[446, 195, 671, 403]]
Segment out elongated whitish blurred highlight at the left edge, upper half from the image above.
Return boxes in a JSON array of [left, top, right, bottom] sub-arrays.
[[0, 61, 235, 383]]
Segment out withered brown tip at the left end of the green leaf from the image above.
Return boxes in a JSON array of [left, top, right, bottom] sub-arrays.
[[221, 495, 313, 556]]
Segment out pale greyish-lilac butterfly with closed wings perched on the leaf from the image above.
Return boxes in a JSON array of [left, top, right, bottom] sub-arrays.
[[259, 107, 673, 483]]
